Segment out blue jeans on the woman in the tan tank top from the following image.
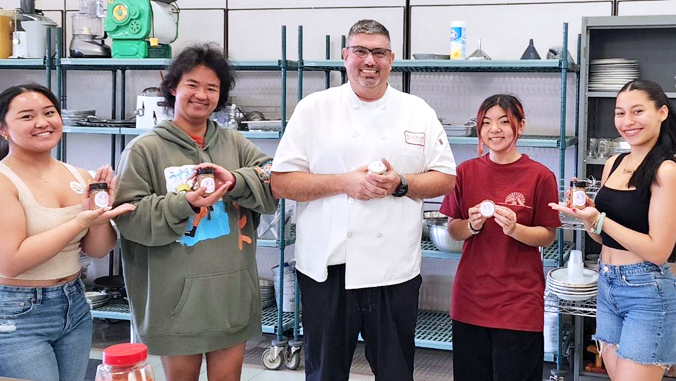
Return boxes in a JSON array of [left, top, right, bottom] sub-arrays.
[[0, 279, 92, 381]]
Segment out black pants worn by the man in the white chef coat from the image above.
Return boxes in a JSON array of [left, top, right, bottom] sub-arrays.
[[298, 265, 422, 381]]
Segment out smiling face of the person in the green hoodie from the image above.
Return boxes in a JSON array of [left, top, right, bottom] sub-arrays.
[[171, 65, 221, 130]]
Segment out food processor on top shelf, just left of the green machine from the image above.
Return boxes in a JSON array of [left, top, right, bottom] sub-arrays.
[[70, 0, 110, 58]]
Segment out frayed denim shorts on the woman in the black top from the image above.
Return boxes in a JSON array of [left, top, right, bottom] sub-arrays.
[[596, 262, 676, 366]]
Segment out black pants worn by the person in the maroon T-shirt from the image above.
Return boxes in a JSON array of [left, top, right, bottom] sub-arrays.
[[453, 320, 545, 381]]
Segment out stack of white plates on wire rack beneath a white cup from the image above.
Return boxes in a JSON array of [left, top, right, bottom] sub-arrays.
[[547, 267, 599, 301]]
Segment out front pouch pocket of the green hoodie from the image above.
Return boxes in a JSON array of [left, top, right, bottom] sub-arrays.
[[171, 268, 260, 335]]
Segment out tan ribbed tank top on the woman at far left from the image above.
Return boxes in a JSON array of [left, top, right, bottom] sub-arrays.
[[0, 162, 87, 280]]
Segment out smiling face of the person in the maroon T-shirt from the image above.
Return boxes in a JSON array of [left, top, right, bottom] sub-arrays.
[[481, 106, 525, 162]]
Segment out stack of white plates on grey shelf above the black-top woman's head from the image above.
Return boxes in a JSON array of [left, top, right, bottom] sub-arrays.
[[589, 58, 639, 91]]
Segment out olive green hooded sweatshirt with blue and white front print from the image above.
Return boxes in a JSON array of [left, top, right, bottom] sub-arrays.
[[115, 121, 277, 356]]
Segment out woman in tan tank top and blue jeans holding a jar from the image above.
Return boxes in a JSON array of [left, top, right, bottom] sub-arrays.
[[0, 84, 134, 381]]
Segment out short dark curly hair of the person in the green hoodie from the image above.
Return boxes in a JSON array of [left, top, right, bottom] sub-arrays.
[[161, 43, 235, 111]]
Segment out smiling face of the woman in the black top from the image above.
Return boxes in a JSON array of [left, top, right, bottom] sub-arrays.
[[615, 90, 669, 147]]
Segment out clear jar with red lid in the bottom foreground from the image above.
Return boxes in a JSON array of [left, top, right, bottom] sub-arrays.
[[95, 343, 155, 381]]
